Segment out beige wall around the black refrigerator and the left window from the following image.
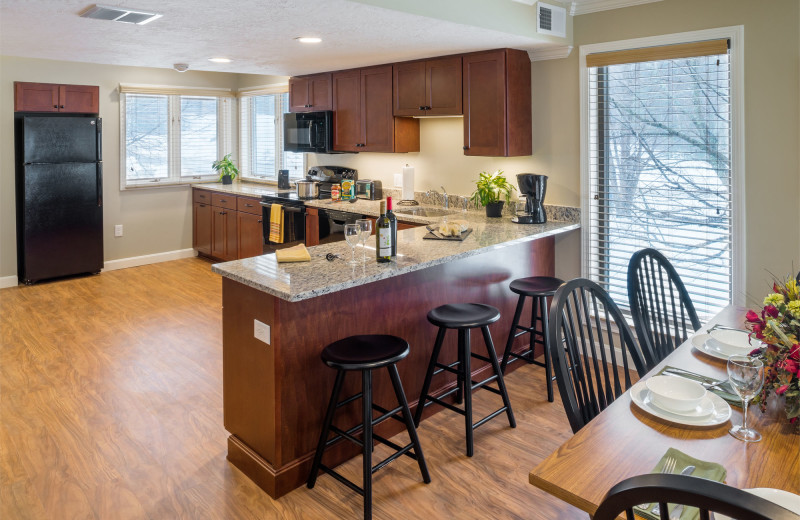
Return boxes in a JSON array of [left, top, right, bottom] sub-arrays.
[[0, 56, 284, 277]]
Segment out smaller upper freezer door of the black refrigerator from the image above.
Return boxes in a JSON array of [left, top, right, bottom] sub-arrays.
[[22, 116, 102, 164]]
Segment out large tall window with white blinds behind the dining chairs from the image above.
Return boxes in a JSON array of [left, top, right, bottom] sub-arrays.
[[584, 40, 734, 318]]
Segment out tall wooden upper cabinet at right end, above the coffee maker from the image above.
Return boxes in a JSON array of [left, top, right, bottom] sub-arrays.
[[463, 49, 533, 157]]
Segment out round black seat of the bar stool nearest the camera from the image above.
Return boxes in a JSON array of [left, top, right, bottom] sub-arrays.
[[321, 334, 409, 370]]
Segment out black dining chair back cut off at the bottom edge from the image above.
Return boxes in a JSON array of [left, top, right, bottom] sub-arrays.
[[594, 474, 800, 520]]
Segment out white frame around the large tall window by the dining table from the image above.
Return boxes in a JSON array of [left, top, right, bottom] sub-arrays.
[[578, 25, 747, 306]]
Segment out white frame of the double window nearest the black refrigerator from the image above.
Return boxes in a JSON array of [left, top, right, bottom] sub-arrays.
[[119, 84, 238, 191]]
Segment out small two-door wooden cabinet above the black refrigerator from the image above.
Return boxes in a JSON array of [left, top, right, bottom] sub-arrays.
[[14, 81, 100, 114]]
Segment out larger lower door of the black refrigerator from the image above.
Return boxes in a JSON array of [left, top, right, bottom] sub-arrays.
[[20, 163, 103, 282]]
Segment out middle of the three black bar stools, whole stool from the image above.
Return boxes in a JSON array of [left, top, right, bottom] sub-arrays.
[[414, 303, 517, 457]]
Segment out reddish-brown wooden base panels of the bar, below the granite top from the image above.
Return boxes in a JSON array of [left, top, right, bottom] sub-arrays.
[[223, 237, 554, 498]]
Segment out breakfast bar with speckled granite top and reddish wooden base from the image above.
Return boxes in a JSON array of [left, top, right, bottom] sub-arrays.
[[213, 214, 579, 498]]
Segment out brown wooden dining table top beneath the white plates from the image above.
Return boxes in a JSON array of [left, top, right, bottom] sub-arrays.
[[529, 307, 800, 515]]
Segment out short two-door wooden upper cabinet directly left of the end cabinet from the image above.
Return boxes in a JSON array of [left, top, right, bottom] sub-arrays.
[[394, 56, 463, 116]]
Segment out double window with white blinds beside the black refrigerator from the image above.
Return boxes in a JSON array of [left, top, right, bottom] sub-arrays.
[[120, 85, 235, 188]]
